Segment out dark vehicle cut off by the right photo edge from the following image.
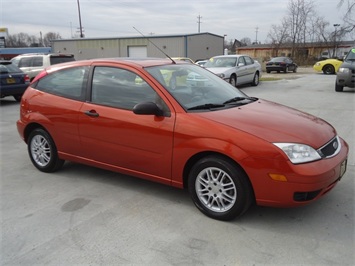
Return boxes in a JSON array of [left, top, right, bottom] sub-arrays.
[[335, 48, 355, 91]]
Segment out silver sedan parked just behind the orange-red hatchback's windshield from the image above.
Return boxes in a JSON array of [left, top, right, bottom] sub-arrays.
[[204, 55, 262, 86]]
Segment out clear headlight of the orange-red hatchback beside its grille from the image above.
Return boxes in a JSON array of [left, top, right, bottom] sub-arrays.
[[273, 143, 322, 164]]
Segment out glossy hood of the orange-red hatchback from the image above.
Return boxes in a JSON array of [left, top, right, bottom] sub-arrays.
[[200, 100, 336, 148]]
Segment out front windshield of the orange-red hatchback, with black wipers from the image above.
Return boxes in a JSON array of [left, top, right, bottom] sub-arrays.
[[146, 64, 255, 111]]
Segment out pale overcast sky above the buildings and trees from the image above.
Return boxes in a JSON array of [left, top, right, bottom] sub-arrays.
[[0, 0, 345, 43]]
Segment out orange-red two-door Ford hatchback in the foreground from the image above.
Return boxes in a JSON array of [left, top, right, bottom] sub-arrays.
[[17, 58, 348, 220]]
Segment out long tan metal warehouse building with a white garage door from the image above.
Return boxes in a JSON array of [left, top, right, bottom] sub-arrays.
[[52, 33, 224, 61]]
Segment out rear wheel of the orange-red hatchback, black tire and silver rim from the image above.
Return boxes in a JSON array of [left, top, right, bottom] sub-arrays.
[[27, 128, 64, 173]]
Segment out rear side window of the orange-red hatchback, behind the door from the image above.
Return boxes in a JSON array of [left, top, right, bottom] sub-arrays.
[[33, 67, 88, 100]]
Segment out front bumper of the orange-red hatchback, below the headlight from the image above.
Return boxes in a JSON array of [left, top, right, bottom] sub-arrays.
[[243, 138, 349, 207]]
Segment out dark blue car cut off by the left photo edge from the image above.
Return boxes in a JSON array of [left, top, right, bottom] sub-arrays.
[[0, 61, 30, 102]]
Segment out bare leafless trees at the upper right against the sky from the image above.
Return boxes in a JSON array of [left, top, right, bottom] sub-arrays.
[[268, 0, 355, 58]]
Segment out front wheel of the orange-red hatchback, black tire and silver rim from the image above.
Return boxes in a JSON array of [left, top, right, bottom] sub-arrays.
[[188, 156, 254, 221]]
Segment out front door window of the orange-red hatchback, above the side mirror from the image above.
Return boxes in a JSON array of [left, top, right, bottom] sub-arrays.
[[91, 67, 160, 110]]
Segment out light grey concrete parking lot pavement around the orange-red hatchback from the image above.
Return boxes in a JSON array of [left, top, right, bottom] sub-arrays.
[[0, 71, 355, 266]]
